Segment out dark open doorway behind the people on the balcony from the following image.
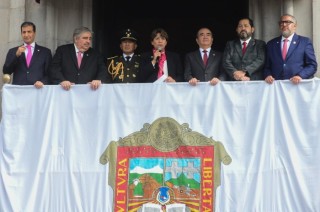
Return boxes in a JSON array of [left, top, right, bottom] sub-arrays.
[[93, 0, 248, 57]]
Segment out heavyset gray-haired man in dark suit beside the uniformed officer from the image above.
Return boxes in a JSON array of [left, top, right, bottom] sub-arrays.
[[49, 27, 111, 90]]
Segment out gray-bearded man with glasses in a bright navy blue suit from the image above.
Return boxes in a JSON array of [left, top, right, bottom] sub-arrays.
[[264, 14, 318, 84]]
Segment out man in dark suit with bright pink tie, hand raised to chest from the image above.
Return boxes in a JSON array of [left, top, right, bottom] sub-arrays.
[[3, 22, 52, 88]]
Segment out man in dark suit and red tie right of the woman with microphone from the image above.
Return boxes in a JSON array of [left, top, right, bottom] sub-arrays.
[[184, 28, 226, 85]]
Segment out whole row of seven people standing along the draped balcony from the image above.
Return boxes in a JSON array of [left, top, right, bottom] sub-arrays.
[[3, 14, 317, 90]]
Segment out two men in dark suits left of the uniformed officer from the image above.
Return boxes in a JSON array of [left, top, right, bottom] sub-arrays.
[[3, 22, 107, 90]]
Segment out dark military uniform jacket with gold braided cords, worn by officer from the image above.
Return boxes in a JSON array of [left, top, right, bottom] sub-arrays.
[[107, 54, 140, 83]]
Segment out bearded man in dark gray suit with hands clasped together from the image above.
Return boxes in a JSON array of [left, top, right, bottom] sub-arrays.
[[223, 18, 266, 81]]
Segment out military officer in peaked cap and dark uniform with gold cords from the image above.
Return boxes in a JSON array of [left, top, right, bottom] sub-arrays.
[[107, 29, 140, 83]]
